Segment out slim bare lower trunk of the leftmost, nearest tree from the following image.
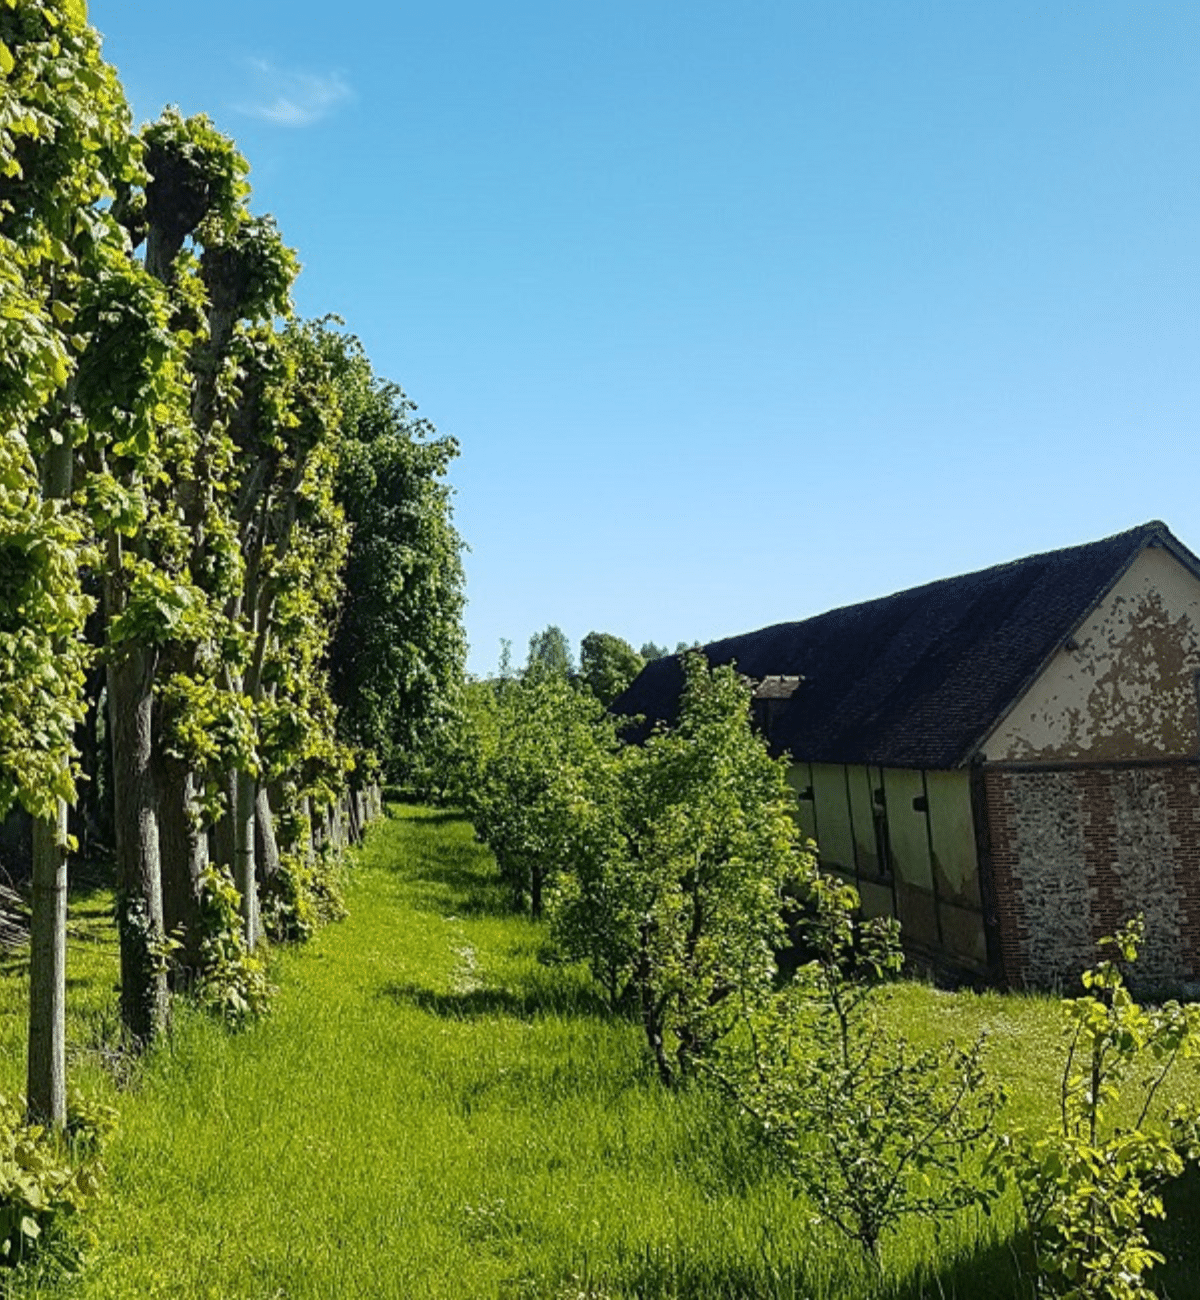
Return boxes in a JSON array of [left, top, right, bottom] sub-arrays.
[[26, 800, 66, 1128]]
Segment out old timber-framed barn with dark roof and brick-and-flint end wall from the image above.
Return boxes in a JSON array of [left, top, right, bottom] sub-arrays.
[[614, 521, 1200, 988]]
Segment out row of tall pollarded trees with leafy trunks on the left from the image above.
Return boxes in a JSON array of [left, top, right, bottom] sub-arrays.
[[0, 0, 464, 1125]]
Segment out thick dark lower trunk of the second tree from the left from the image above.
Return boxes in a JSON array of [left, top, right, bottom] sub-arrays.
[[108, 647, 168, 1047]]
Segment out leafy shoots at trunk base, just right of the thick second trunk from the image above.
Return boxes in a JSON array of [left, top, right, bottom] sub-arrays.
[[194, 867, 276, 1026]]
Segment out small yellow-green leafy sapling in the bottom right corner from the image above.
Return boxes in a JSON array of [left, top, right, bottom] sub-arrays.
[[993, 918, 1200, 1300]]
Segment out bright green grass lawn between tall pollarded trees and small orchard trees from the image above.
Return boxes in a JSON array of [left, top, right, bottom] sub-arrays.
[[0, 809, 1200, 1300]]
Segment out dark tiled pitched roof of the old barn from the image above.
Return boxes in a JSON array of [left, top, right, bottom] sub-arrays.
[[612, 521, 1200, 768]]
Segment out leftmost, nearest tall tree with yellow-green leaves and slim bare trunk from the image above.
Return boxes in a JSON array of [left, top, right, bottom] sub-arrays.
[[0, 0, 143, 1123]]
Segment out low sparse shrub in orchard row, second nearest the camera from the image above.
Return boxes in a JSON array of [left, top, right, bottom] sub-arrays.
[[719, 875, 1004, 1262]]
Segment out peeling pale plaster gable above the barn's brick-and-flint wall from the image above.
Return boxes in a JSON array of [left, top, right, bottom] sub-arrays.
[[983, 547, 1200, 762]]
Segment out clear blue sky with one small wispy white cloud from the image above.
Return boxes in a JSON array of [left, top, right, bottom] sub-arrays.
[[91, 0, 1200, 672]]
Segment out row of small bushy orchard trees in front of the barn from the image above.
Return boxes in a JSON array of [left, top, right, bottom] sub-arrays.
[[460, 650, 1200, 1300]]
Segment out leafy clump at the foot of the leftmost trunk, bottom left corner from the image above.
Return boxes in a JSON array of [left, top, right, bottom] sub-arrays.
[[0, 1096, 114, 1274]]
